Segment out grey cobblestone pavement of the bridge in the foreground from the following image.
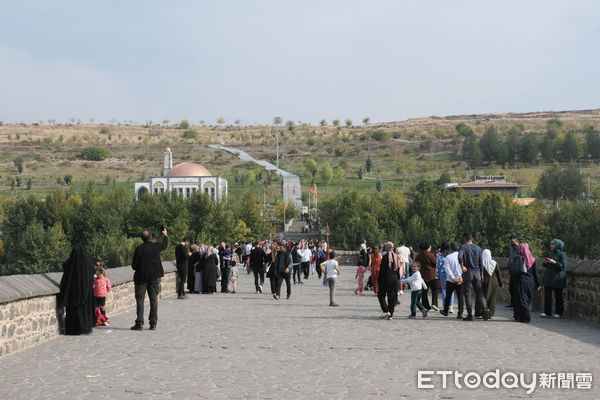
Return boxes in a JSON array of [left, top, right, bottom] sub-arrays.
[[0, 267, 600, 400]]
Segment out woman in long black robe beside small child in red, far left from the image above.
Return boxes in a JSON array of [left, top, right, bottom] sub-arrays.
[[59, 244, 96, 335]]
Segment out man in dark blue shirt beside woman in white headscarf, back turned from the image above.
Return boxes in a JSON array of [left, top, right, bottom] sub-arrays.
[[458, 233, 489, 321]]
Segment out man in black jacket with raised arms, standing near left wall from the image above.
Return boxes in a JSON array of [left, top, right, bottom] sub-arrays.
[[131, 228, 169, 331]]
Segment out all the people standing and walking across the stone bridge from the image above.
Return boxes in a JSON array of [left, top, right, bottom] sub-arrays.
[[59, 228, 567, 334]]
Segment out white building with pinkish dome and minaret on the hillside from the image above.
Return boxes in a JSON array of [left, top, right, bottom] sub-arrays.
[[135, 147, 227, 202]]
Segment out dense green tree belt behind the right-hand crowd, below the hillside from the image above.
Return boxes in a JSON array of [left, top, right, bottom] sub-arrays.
[[319, 181, 600, 258]]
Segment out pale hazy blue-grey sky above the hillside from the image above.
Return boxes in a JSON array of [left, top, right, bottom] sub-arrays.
[[0, 0, 600, 124]]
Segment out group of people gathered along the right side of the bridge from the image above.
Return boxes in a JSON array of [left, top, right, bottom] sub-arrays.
[[354, 233, 567, 323]]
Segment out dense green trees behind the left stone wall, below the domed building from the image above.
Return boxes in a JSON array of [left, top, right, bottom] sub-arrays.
[[0, 183, 270, 274]]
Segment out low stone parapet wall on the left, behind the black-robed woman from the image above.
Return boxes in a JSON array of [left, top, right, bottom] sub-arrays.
[[0, 261, 176, 357]]
